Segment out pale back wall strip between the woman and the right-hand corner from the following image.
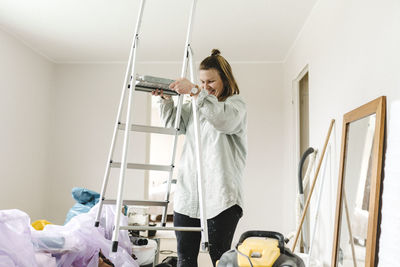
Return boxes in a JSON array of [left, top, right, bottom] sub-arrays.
[[232, 63, 292, 237]]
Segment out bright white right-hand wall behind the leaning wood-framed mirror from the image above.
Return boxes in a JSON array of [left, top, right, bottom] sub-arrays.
[[283, 0, 400, 266]]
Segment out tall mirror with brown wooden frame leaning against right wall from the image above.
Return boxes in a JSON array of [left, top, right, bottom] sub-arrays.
[[331, 96, 386, 267]]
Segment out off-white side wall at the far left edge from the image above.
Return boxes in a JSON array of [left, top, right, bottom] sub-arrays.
[[0, 30, 54, 220]]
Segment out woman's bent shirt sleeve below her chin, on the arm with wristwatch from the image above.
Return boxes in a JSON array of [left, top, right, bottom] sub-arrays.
[[197, 90, 246, 134]]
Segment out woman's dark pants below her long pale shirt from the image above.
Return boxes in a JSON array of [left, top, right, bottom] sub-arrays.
[[174, 205, 243, 267]]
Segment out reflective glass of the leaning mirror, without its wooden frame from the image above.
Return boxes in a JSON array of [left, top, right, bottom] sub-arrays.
[[336, 114, 376, 267]]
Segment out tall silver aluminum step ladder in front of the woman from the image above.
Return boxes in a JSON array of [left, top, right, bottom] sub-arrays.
[[95, 0, 208, 252]]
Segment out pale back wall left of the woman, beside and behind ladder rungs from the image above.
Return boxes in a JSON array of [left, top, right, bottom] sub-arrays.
[[47, 64, 149, 223]]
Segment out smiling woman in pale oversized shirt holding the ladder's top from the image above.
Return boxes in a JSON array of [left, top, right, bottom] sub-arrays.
[[153, 49, 247, 267]]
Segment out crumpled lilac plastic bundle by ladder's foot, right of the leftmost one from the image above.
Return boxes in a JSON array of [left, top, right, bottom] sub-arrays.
[[32, 205, 139, 267]]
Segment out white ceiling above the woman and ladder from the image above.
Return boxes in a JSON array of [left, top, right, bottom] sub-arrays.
[[0, 0, 317, 63]]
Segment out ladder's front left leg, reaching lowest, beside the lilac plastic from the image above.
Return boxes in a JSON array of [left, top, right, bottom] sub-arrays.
[[112, 0, 145, 252]]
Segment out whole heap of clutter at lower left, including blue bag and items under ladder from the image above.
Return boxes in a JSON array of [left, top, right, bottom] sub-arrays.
[[0, 188, 176, 267]]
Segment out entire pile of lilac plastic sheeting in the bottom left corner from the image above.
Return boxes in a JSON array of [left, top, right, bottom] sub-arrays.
[[0, 205, 139, 267]]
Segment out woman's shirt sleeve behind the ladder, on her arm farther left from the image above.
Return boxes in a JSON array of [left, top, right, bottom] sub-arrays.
[[158, 97, 190, 134]]
